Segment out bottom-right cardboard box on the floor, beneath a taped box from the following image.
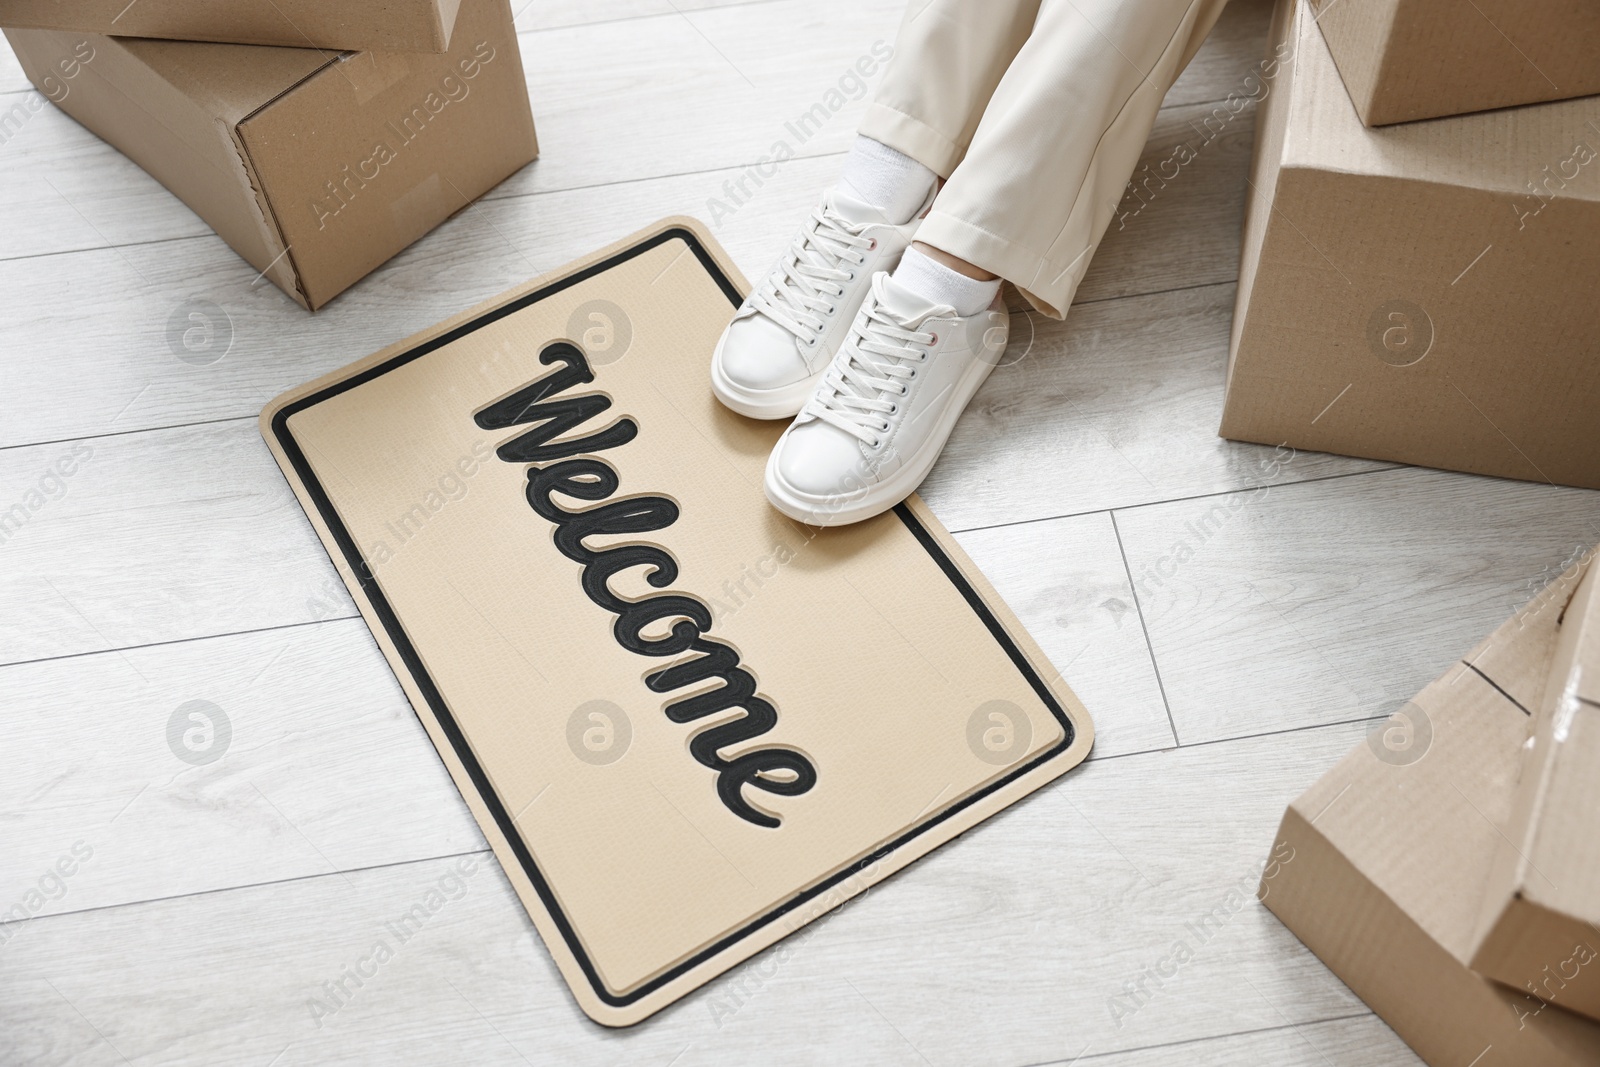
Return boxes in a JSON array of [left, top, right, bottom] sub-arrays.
[[1261, 556, 1600, 1067]]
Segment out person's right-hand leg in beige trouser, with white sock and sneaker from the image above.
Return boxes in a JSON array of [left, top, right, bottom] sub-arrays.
[[766, 0, 1226, 525]]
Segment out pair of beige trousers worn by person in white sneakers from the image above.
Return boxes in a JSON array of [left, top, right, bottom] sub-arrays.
[[861, 0, 1227, 318]]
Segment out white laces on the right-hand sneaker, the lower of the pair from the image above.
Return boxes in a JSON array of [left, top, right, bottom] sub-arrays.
[[805, 280, 939, 448]]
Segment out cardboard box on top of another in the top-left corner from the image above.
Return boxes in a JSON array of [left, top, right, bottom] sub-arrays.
[[0, 0, 461, 53]]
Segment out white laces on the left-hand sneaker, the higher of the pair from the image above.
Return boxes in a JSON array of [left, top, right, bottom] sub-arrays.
[[750, 203, 877, 349]]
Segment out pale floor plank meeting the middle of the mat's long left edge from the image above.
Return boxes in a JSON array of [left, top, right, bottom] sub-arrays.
[[0, 617, 485, 915]]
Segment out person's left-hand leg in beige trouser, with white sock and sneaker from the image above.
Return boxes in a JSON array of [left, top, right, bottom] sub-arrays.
[[710, 0, 1038, 419]]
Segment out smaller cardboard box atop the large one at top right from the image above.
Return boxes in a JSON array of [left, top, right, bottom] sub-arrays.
[[1312, 0, 1600, 126]]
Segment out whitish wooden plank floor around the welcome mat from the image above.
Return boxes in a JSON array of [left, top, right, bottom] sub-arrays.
[[0, 0, 1600, 1067]]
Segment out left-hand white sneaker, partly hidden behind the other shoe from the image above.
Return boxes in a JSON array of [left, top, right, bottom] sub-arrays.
[[710, 189, 934, 419]]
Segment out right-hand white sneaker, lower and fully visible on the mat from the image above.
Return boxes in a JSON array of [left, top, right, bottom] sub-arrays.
[[766, 274, 1011, 526]]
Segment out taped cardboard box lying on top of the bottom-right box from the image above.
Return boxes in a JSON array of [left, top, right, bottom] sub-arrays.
[[1472, 568, 1600, 1019]]
